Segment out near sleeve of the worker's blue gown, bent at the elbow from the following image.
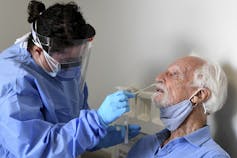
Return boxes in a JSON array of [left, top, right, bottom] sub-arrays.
[[0, 72, 106, 158]]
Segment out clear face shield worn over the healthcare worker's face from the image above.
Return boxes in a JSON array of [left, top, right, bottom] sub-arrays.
[[32, 21, 92, 92]]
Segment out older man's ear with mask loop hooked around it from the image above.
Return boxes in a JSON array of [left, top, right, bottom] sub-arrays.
[[191, 88, 211, 105]]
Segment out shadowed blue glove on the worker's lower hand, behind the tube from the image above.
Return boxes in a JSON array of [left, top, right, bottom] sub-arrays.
[[90, 124, 141, 151]]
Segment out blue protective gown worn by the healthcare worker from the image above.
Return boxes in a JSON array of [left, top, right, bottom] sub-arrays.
[[0, 43, 106, 158]]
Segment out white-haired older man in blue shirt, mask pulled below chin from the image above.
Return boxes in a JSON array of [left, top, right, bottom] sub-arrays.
[[128, 56, 230, 158]]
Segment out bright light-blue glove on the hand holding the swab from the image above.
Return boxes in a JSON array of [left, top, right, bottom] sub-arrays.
[[97, 91, 134, 125]]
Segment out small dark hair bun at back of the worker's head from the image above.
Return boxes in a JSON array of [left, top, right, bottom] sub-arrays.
[[28, 0, 45, 23]]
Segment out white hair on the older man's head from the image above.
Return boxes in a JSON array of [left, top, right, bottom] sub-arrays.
[[193, 63, 228, 114]]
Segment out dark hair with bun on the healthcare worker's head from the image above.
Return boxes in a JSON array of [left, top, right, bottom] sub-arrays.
[[28, 0, 95, 51]]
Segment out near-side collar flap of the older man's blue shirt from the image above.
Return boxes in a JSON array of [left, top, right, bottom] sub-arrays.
[[184, 126, 211, 146]]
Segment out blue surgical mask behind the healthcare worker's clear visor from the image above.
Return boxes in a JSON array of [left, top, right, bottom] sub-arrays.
[[57, 66, 81, 81]]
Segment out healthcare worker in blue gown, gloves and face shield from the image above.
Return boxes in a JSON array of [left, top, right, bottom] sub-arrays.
[[0, 1, 140, 158]]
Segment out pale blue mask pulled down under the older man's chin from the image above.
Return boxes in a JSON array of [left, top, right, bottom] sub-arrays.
[[160, 89, 201, 131]]
